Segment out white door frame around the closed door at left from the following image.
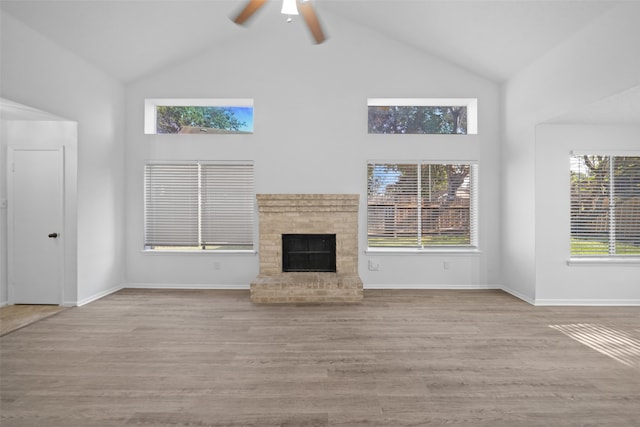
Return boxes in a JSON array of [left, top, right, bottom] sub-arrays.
[[6, 146, 66, 305]]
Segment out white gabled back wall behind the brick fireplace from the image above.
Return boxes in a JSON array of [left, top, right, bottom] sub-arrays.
[[126, 11, 500, 288]]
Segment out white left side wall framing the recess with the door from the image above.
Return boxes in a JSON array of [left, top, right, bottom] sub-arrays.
[[0, 12, 125, 305]]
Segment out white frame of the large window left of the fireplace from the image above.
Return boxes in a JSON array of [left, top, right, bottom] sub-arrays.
[[142, 160, 257, 254]]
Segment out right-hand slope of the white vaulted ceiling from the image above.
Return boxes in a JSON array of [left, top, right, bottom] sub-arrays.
[[318, 0, 615, 82]]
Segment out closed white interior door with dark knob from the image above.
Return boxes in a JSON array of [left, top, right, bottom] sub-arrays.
[[8, 148, 64, 304]]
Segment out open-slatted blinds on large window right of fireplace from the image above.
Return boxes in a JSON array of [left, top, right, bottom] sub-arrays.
[[367, 162, 477, 248]]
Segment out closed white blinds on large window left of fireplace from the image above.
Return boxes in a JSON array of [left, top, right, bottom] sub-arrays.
[[144, 162, 254, 250]]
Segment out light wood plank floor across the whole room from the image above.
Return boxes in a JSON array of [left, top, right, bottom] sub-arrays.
[[0, 290, 640, 427]]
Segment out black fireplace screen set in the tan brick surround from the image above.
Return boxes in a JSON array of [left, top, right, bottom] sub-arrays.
[[282, 234, 336, 273]]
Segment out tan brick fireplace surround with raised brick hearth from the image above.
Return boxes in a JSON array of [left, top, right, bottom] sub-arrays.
[[251, 194, 363, 303]]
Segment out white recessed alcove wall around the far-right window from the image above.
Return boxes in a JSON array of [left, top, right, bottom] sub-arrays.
[[536, 125, 640, 305]]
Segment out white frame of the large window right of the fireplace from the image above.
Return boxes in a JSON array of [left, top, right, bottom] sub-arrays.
[[365, 160, 480, 254]]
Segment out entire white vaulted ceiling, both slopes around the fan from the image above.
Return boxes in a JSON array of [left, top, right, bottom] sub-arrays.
[[0, 0, 618, 82]]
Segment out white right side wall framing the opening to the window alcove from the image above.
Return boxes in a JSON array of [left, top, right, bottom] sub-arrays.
[[501, 2, 640, 302]]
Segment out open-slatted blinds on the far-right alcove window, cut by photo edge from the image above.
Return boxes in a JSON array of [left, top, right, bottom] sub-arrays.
[[570, 154, 640, 257]]
